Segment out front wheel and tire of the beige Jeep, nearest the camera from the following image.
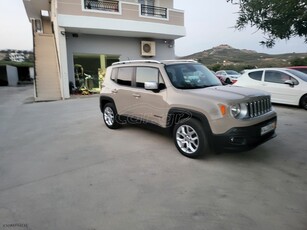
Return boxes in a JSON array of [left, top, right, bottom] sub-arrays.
[[173, 118, 209, 158]]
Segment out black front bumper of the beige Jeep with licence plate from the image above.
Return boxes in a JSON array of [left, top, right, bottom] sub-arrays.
[[212, 117, 277, 152]]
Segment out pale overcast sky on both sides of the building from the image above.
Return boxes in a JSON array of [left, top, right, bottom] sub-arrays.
[[0, 0, 307, 56]]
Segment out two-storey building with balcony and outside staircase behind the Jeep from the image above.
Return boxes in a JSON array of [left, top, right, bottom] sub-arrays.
[[23, 0, 185, 101]]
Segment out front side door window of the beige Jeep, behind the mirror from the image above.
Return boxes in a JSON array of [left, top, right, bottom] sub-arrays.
[[135, 67, 164, 88]]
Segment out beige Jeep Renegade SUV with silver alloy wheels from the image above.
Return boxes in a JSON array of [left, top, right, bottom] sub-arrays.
[[100, 60, 277, 158]]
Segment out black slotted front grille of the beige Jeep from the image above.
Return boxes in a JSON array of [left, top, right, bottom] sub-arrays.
[[247, 96, 272, 118]]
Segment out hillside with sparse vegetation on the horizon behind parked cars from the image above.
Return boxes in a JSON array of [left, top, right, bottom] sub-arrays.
[[181, 45, 307, 67]]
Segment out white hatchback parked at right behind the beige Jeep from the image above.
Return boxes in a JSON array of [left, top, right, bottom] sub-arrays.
[[234, 68, 307, 110]]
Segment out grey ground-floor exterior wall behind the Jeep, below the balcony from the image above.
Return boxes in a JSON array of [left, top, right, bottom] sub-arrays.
[[66, 34, 175, 81]]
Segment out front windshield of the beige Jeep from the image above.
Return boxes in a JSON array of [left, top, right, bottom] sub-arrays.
[[165, 63, 222, 89]]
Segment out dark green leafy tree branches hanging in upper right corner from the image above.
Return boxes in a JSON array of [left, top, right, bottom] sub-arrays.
[[227, 0, 307, 48]]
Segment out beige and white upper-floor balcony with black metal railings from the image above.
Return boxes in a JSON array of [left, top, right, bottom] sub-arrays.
[[57, 0, 185, 39]]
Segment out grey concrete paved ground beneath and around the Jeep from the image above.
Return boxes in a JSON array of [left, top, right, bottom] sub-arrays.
[[0, 87, 307, 230]]
